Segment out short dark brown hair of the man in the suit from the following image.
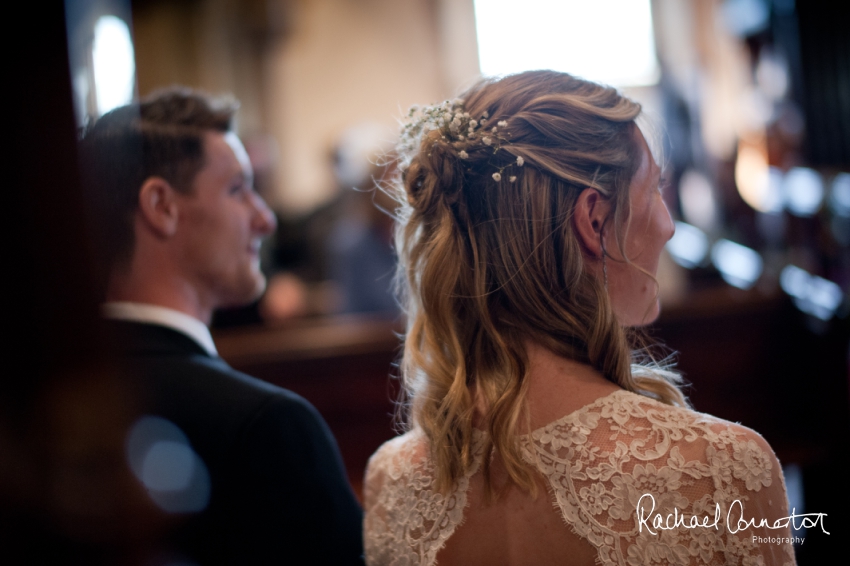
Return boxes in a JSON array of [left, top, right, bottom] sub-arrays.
[[80, 87, 238, 273]]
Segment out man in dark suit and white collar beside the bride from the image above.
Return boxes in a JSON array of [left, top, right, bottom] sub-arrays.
[[81, 89, 362, 565]]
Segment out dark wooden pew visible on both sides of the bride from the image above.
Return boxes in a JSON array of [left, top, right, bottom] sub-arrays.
[[215, 286, 850, 508]]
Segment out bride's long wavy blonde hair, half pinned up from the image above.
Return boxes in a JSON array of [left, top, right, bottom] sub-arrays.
[[390, 71, 686, 492]]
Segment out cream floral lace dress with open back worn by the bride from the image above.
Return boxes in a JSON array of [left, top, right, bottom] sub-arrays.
[[364, 391, 794, 566]]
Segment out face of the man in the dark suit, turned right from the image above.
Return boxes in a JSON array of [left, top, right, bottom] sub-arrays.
[[176, 132, 276, 309]]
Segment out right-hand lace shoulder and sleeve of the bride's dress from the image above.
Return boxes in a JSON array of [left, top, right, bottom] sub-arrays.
[[524, 392, 794, 566]]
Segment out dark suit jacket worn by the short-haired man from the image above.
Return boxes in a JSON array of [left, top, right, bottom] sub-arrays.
[[107, 321, 363, 566]]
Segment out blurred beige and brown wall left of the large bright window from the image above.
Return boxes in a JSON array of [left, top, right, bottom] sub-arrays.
[[133, 0, 478, 213]]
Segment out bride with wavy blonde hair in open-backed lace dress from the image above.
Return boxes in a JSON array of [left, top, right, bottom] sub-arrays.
[[364, 71, 794, 565]]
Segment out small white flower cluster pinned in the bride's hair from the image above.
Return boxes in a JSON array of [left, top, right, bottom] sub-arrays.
[[398, 98, 524, 183]]
